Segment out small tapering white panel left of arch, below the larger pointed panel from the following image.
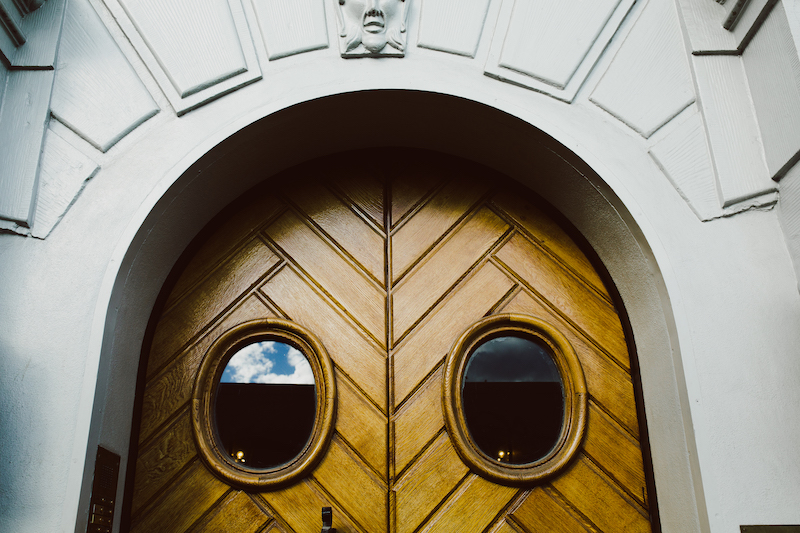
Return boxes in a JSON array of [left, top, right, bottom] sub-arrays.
[[31, 125, 100, 239]]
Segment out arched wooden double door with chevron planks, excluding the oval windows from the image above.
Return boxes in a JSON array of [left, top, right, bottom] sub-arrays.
[[126, 149, 651, 533]]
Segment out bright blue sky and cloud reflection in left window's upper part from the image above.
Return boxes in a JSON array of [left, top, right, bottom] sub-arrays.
[[220, 341, 314, 385]]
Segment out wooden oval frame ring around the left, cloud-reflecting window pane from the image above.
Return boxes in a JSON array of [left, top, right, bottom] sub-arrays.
[[192, 318, 336, 491]]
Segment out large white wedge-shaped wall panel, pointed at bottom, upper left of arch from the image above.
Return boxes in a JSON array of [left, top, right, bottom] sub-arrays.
[[50, 0, 158, 152]]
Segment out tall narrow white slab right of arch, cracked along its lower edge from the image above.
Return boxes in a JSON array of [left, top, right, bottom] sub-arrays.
[[692, 55, 775, 207]]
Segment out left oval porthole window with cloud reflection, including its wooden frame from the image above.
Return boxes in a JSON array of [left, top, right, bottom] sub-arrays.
[[192, 319, 335, 490]]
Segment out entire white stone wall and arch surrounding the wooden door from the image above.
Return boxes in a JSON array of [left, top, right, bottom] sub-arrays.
[[0, 0, 800, 533]]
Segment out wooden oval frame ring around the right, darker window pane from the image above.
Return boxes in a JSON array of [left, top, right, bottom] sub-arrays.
[[442, 314, 588, 485]]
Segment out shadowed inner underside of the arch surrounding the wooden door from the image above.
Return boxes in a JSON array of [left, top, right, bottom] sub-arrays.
[[82, 90, 704, 531]]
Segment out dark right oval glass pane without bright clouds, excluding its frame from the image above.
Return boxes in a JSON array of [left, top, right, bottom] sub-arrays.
[[462, 336, 564, 464]]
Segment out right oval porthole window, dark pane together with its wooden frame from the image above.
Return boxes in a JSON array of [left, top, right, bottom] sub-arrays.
[[443, 314, 586, 484]]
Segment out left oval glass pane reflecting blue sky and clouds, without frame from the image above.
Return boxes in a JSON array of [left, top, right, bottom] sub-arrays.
[[216, 341, 316, 468]]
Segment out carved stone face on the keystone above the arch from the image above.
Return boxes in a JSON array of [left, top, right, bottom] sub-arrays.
[[337, 0, 406, 57]]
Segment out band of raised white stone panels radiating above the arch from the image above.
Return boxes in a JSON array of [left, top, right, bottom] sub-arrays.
[[0, 0, 800, 235]]
